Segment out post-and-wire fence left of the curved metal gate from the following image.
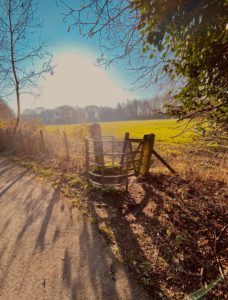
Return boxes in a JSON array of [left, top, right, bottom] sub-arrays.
[[0, 123, 88, 163]]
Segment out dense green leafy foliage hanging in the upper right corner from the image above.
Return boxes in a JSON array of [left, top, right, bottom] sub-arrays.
[[132, 0, 228, 139]]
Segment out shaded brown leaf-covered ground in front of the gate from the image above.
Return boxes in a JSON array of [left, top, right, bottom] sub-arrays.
[[88, 173, 228, 299]]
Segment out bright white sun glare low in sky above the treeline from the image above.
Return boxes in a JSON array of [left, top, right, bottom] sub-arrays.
[[22, 51, 132, 108]]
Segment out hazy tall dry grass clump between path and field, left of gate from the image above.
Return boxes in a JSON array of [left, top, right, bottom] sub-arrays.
[[0, 121, 88, 175]]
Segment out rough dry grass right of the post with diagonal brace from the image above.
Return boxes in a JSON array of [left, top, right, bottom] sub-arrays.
[[152, 144, 228, 183]]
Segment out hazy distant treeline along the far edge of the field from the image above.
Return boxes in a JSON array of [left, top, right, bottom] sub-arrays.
[[22, 97, 173, 124]]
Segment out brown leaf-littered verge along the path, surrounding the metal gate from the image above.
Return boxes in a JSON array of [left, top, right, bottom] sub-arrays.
[[0, 121, 228, 299]]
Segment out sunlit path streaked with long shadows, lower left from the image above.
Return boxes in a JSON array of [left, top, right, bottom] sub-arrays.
[[0, 158, 148, 300]]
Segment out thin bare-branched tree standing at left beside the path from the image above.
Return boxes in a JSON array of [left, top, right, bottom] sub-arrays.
[[0, 0, 52, 132]]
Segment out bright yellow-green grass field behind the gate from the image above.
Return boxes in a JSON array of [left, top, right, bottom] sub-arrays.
[[46, 120, 196, 144]]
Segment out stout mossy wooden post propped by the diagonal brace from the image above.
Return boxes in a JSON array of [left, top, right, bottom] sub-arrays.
[[141, 133, 155, 176]]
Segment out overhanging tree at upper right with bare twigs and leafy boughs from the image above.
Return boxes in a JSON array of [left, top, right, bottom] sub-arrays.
[[59, 0, 228, 143]]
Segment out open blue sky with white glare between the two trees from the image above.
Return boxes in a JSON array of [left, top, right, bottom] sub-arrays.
[[10, 0, 159, 109]]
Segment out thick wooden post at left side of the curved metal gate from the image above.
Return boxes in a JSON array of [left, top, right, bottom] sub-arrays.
[[89, 123, 104, 166]]
